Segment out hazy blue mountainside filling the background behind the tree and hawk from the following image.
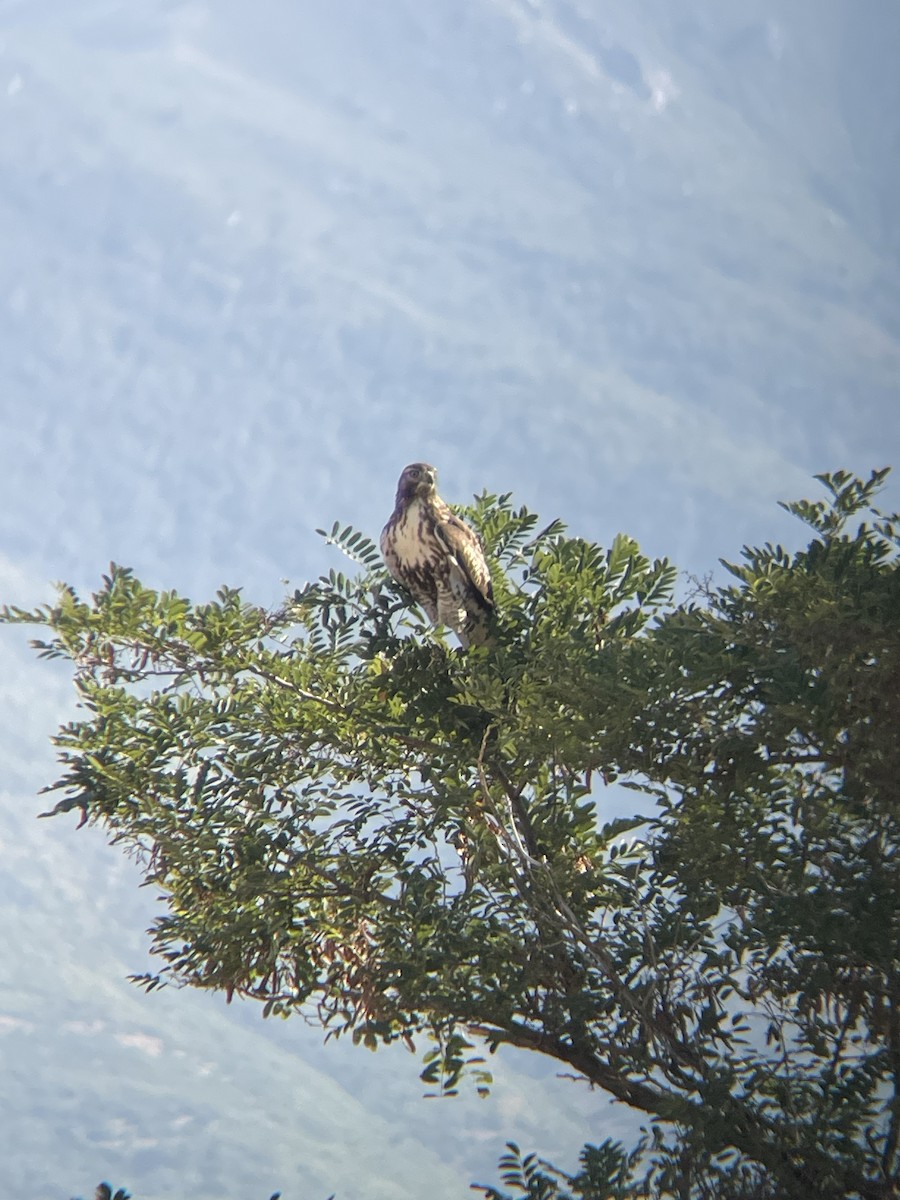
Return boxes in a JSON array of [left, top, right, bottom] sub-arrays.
[[0, 0, 900, 1200]]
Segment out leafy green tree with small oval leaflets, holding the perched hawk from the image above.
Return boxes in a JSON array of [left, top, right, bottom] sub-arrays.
[[4, 472, 900, 1200]]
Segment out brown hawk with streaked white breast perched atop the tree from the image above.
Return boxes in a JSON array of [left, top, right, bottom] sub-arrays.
[[382, 462, 493, 647]]
